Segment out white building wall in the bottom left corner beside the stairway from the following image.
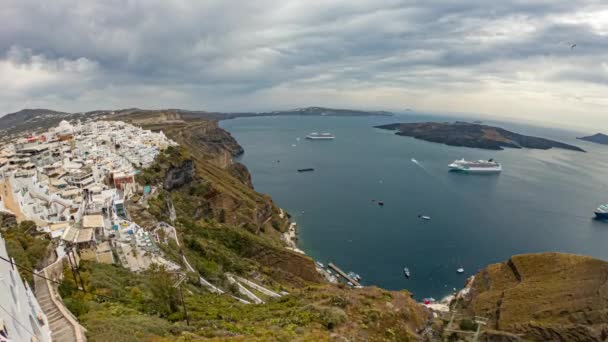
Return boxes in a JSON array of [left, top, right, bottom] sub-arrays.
[[0, 236, 51, 342]]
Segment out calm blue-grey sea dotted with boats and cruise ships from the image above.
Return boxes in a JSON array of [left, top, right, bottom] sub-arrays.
[[222, 114, 608, 299]]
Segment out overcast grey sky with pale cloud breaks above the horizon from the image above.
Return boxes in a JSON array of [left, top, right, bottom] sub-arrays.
[[0, 0, 608, 128]]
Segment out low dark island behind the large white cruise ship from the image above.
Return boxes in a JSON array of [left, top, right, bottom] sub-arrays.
[[376, 122, 585, 152]]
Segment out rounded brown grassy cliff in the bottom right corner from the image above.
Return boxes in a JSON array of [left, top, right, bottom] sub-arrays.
[[458, 253, 608, 341]]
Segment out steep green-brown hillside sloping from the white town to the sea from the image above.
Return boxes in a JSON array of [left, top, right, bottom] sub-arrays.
[[86, 113, 430, 341]]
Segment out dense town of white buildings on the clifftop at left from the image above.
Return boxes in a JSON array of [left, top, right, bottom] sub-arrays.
[[0, 121, 183, 272]]
